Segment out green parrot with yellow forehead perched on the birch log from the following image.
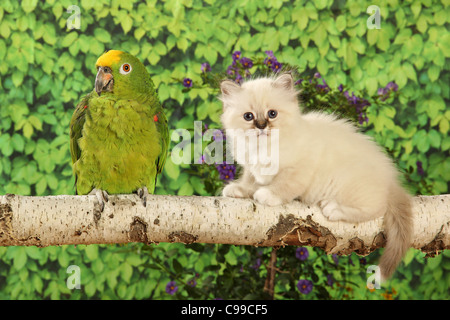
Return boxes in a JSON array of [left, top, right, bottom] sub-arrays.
[[70, 50, 169, 211]]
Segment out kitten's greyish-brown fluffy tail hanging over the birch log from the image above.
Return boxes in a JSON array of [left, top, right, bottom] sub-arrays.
[[379, 184, 414, 280]]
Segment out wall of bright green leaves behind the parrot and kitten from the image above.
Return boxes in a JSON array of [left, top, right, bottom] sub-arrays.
[[0, 0, 450, 299]]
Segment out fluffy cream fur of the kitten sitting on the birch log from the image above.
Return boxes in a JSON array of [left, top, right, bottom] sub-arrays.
[[220, 73, 413, 279]]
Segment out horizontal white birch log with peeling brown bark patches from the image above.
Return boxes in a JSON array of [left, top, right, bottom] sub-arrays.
[[0, 194, 450, 255]]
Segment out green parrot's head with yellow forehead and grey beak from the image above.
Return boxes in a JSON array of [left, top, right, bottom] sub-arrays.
[[95, 50, 154, 99]]
